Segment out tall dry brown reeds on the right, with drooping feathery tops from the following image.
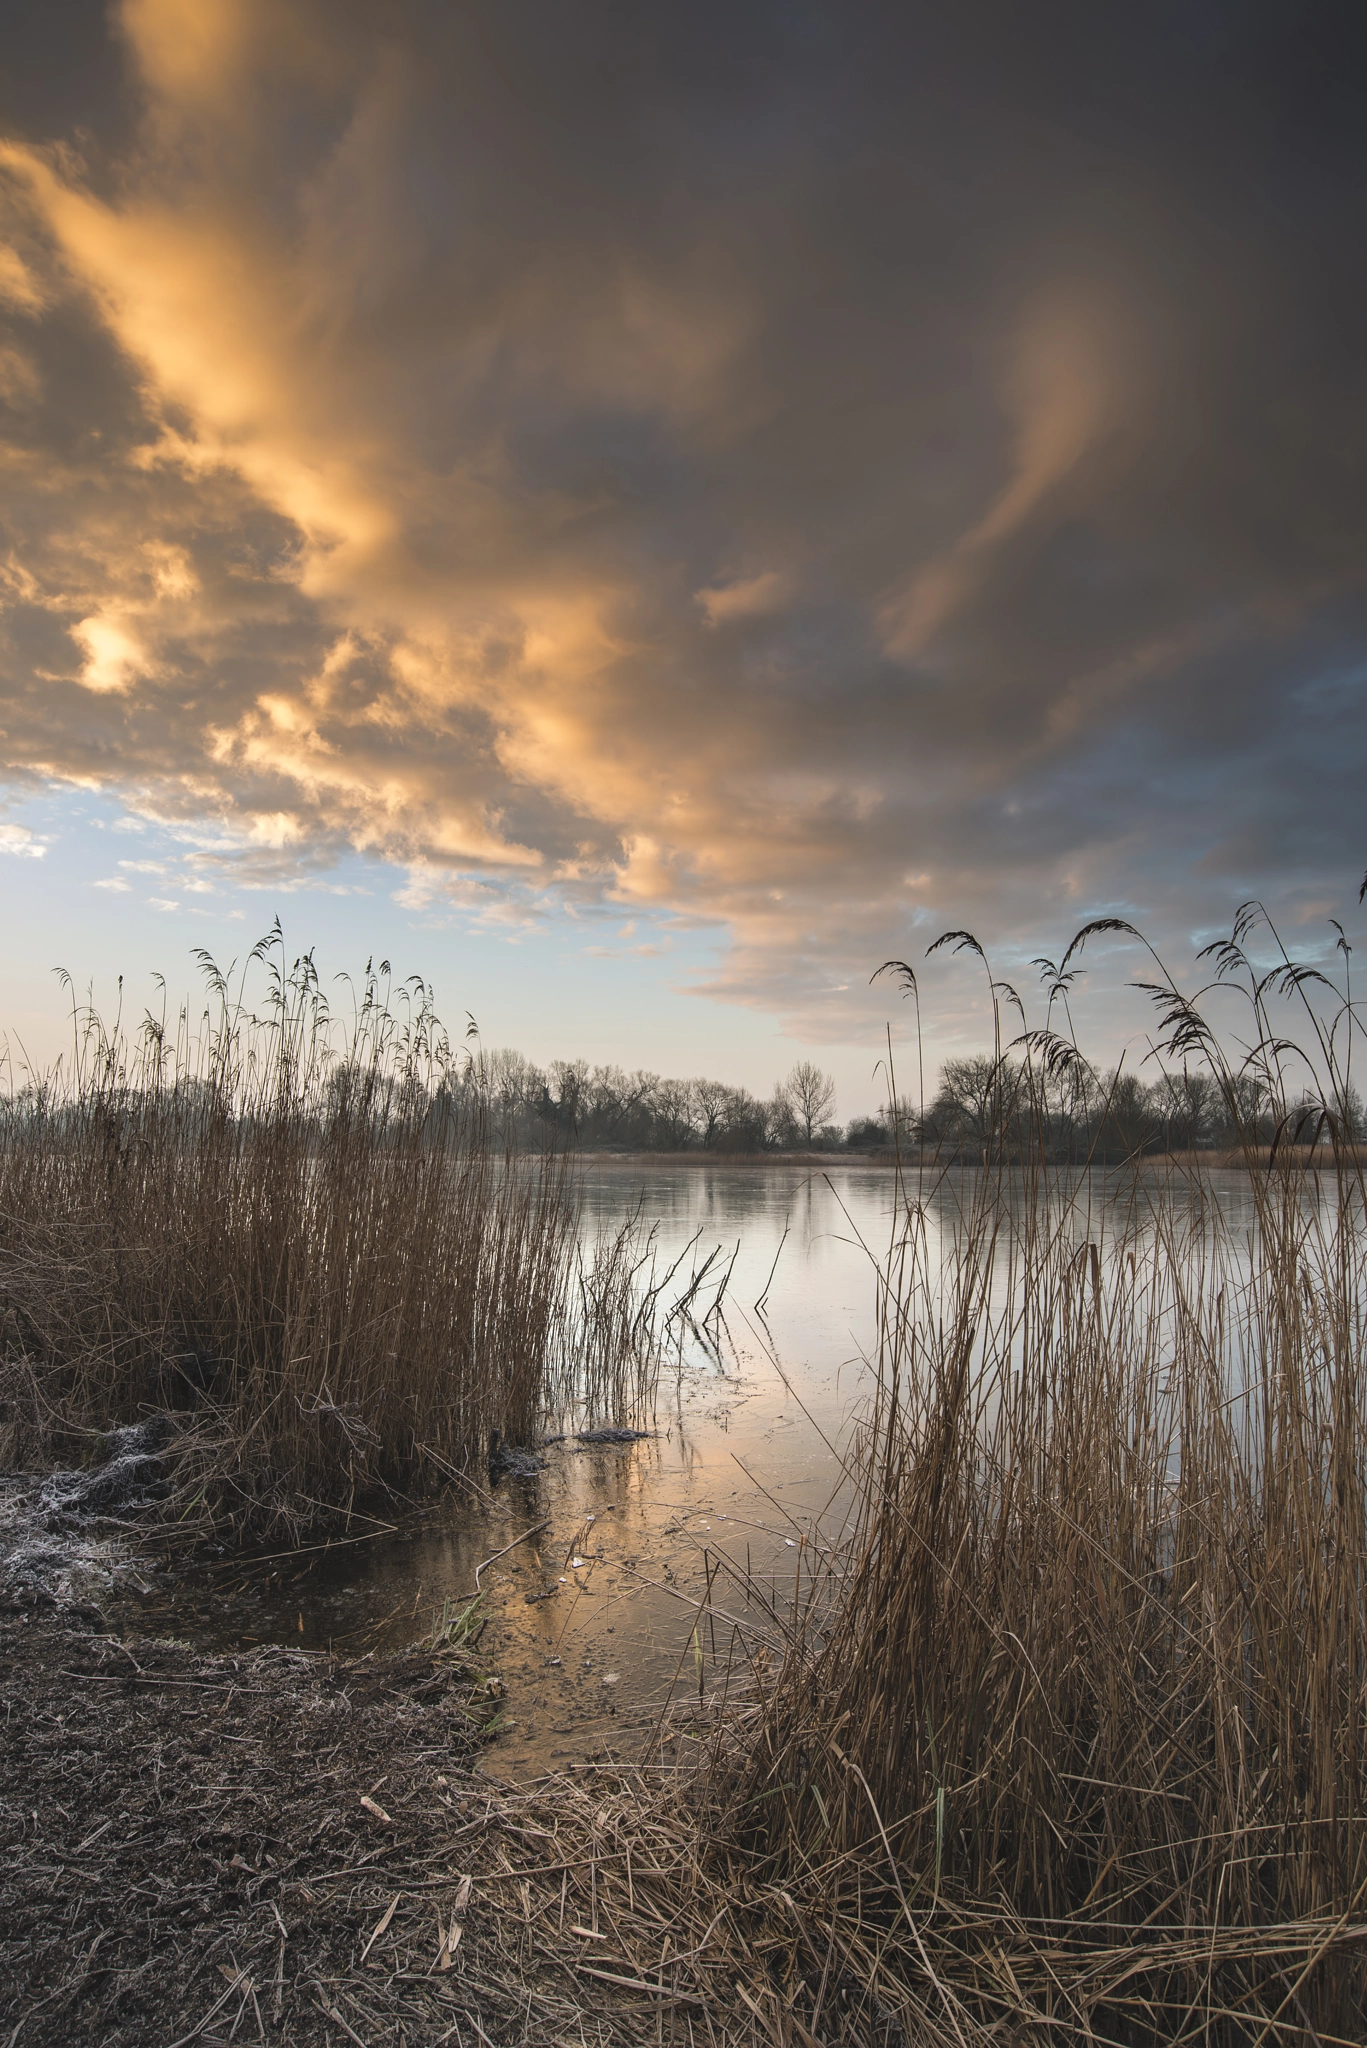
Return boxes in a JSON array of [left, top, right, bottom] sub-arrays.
[[711, 920, 1367, 2048]]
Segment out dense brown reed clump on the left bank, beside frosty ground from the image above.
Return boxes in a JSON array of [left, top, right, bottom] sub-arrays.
[[0, 928, 644, 1534]]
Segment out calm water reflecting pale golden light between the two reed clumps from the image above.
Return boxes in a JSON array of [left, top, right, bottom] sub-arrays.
[[162, 1163, 1270, 1776]]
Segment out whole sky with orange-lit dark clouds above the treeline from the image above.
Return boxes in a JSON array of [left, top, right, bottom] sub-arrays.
[[0, 0, 1367, 1114]]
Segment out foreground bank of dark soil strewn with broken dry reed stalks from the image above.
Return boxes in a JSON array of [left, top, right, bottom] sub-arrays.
[[0, 1610, 844, 2048]]
